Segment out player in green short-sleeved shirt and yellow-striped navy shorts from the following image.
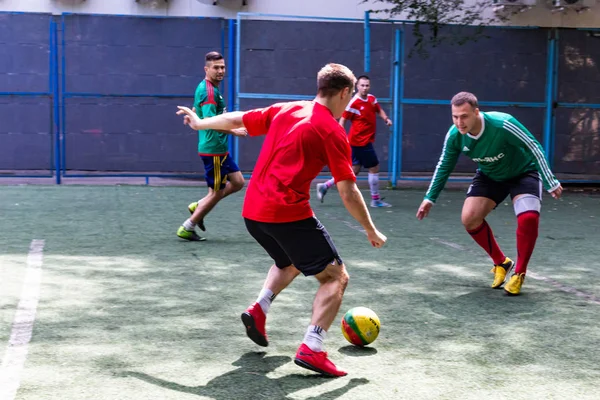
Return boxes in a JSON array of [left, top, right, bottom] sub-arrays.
[[177, 51, 246, 241]]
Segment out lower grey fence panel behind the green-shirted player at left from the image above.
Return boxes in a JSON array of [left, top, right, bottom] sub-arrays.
[[65, 98, 203, 172]]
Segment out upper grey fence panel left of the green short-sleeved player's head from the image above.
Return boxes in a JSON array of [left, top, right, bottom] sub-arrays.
[[65, 15, 223, 94]]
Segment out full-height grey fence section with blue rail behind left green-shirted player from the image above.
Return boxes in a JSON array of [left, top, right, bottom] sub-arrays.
[[60, 14, 225, 181]]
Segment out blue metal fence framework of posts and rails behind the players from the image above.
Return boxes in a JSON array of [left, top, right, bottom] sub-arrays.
[[0, 12, 600, 185]]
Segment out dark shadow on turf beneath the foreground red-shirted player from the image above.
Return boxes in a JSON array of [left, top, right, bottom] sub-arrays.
[[119, 352, 369, 400]]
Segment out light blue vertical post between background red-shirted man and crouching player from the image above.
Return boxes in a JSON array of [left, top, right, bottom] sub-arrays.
[[391, 29, 404, 187]]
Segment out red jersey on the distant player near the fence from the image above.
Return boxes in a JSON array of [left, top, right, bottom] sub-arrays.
[[342, 94, 381, 146]]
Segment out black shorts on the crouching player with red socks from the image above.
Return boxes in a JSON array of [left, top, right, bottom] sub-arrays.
[[467, 170, 542, 205]]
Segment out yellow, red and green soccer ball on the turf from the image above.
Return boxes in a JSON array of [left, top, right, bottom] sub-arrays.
[[342, 307, 381, 346]]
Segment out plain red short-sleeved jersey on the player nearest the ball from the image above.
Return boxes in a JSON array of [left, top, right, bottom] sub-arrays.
[[242, 101, 356, 223]]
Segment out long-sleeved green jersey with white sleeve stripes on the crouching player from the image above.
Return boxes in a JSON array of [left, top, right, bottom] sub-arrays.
[[425, 112, 560, 203]]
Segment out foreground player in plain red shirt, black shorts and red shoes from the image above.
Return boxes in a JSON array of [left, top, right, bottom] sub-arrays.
[[178, 64, 387, 376]]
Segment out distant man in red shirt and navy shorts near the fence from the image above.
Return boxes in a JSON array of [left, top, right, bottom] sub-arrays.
[[317, 75, 392, 207]]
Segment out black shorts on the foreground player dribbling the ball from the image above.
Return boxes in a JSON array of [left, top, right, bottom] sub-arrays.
[[244, 217, 342, 276]]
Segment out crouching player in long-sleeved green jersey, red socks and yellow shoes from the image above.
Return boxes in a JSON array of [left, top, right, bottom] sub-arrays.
[[417, 92, 562, 295]]
